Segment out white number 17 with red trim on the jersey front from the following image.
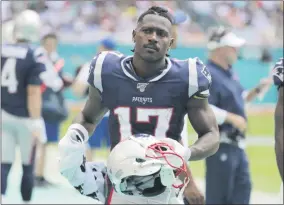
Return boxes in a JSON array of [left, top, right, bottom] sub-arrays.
[[114, 107, 173, 138]]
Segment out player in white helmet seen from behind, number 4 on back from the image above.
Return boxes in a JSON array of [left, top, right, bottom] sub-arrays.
[[1, 10, 46, 203]]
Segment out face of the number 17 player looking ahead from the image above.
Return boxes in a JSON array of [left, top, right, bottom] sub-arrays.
[[133, 14, 173, 62]]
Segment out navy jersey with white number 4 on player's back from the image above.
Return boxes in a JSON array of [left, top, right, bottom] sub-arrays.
[[1, 44, 45, 117]]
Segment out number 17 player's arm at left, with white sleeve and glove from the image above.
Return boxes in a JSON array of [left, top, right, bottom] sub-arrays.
[[59, 54, 108, 200]]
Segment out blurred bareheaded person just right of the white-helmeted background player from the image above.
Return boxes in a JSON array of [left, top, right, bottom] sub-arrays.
[[35, 29, 72, 186]]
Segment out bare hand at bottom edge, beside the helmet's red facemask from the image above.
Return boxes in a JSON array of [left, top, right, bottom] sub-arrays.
[[184, 181, 205, 204]]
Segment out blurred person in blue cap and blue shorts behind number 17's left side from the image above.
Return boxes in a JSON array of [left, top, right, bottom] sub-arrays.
[[72, 37, 116, 161]]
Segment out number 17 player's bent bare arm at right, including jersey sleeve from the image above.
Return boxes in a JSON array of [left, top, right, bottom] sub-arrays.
[[187, 59, 220, 161]]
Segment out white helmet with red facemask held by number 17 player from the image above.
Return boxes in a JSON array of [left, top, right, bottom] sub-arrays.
[[107, 134, 188, 197]]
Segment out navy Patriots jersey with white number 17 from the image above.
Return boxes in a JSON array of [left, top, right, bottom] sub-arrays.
[[88, 52, 211, 147]]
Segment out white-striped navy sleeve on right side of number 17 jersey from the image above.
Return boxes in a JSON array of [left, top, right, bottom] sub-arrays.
[[188, 57, 212, 99]]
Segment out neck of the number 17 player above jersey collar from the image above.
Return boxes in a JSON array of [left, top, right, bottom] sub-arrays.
[[132, 54, 167, 78]]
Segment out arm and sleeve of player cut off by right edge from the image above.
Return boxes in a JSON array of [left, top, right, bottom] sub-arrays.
[[273, 58, 284, 181]]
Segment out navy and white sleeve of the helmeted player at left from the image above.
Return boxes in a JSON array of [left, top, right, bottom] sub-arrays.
[[27, 48, 47, 85]]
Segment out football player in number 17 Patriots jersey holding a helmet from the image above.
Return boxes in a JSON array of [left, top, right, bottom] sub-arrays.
[[59, 7, 219, 204]]
